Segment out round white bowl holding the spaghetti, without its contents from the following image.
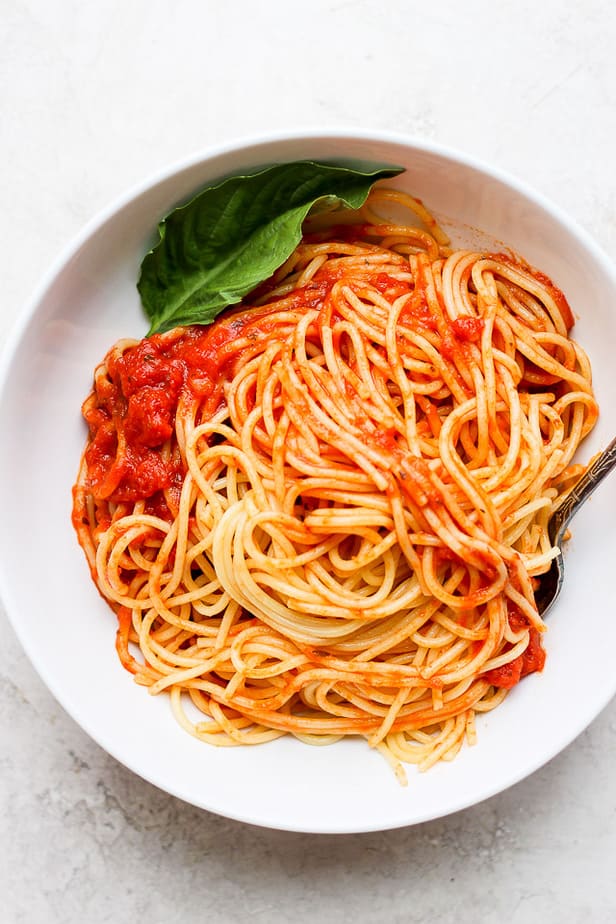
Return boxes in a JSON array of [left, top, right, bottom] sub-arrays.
[[0, 132, 616, 832]]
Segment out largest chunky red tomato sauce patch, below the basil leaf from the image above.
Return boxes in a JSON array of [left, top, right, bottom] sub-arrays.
[[83, 316, 249, 516]]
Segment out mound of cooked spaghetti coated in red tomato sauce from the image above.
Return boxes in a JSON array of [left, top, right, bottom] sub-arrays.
[[73, 189, 597, 780]]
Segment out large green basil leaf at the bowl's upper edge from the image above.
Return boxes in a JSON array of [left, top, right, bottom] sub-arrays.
[[137, 161, 403, 336]]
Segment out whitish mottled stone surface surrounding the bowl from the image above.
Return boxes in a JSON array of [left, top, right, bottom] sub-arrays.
[[0, 0, 616, 924]]
